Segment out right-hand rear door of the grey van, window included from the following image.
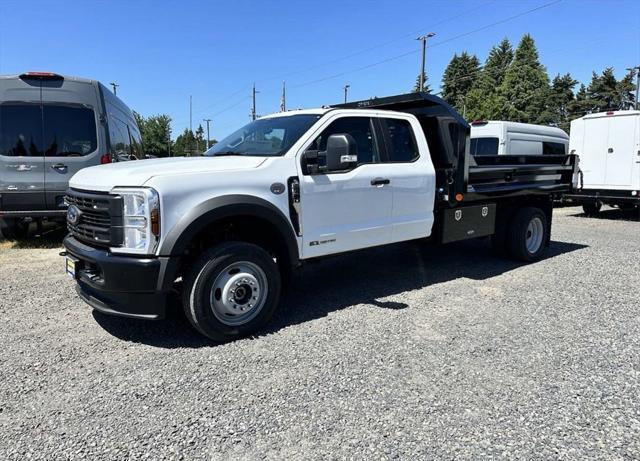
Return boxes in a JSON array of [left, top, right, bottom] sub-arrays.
[[42, 79, 103, 209]]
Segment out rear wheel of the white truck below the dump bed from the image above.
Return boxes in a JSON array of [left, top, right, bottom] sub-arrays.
[[506, 207, 549, 262]]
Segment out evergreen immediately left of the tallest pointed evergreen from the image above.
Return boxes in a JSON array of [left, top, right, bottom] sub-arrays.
[[466, 38, 513, 120]]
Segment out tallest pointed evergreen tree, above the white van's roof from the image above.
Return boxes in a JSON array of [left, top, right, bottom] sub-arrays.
[[498, 34, 552, 124]]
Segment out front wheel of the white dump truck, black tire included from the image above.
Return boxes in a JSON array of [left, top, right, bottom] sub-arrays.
[[182, 242, 282, 342]]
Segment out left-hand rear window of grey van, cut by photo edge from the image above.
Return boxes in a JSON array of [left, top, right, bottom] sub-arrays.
[[0, 103, 42, 157]]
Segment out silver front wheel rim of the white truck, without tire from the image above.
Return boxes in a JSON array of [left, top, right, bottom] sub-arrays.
[[211, 261, 269, 326]]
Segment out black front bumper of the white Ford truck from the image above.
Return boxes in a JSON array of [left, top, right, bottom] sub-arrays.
[[64, 236, 177, 320]]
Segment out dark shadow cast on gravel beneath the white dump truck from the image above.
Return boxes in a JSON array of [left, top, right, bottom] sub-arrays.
[[94, 241, 585, 348]]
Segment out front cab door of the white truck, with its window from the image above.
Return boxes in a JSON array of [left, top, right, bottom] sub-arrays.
[[300, 115, 393, 258]]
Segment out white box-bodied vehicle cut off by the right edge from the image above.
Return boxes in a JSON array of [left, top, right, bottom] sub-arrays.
[[567, 110, 640, 214]]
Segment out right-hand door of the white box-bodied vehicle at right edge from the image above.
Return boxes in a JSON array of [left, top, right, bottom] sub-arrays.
[[606, 115, 638, 189]]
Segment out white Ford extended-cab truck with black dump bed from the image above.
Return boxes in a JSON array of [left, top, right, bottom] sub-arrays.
[[63, 93, 578, 341]]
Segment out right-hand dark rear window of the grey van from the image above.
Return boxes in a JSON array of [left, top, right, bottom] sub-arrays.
[[42, 104, 98, 157]]
